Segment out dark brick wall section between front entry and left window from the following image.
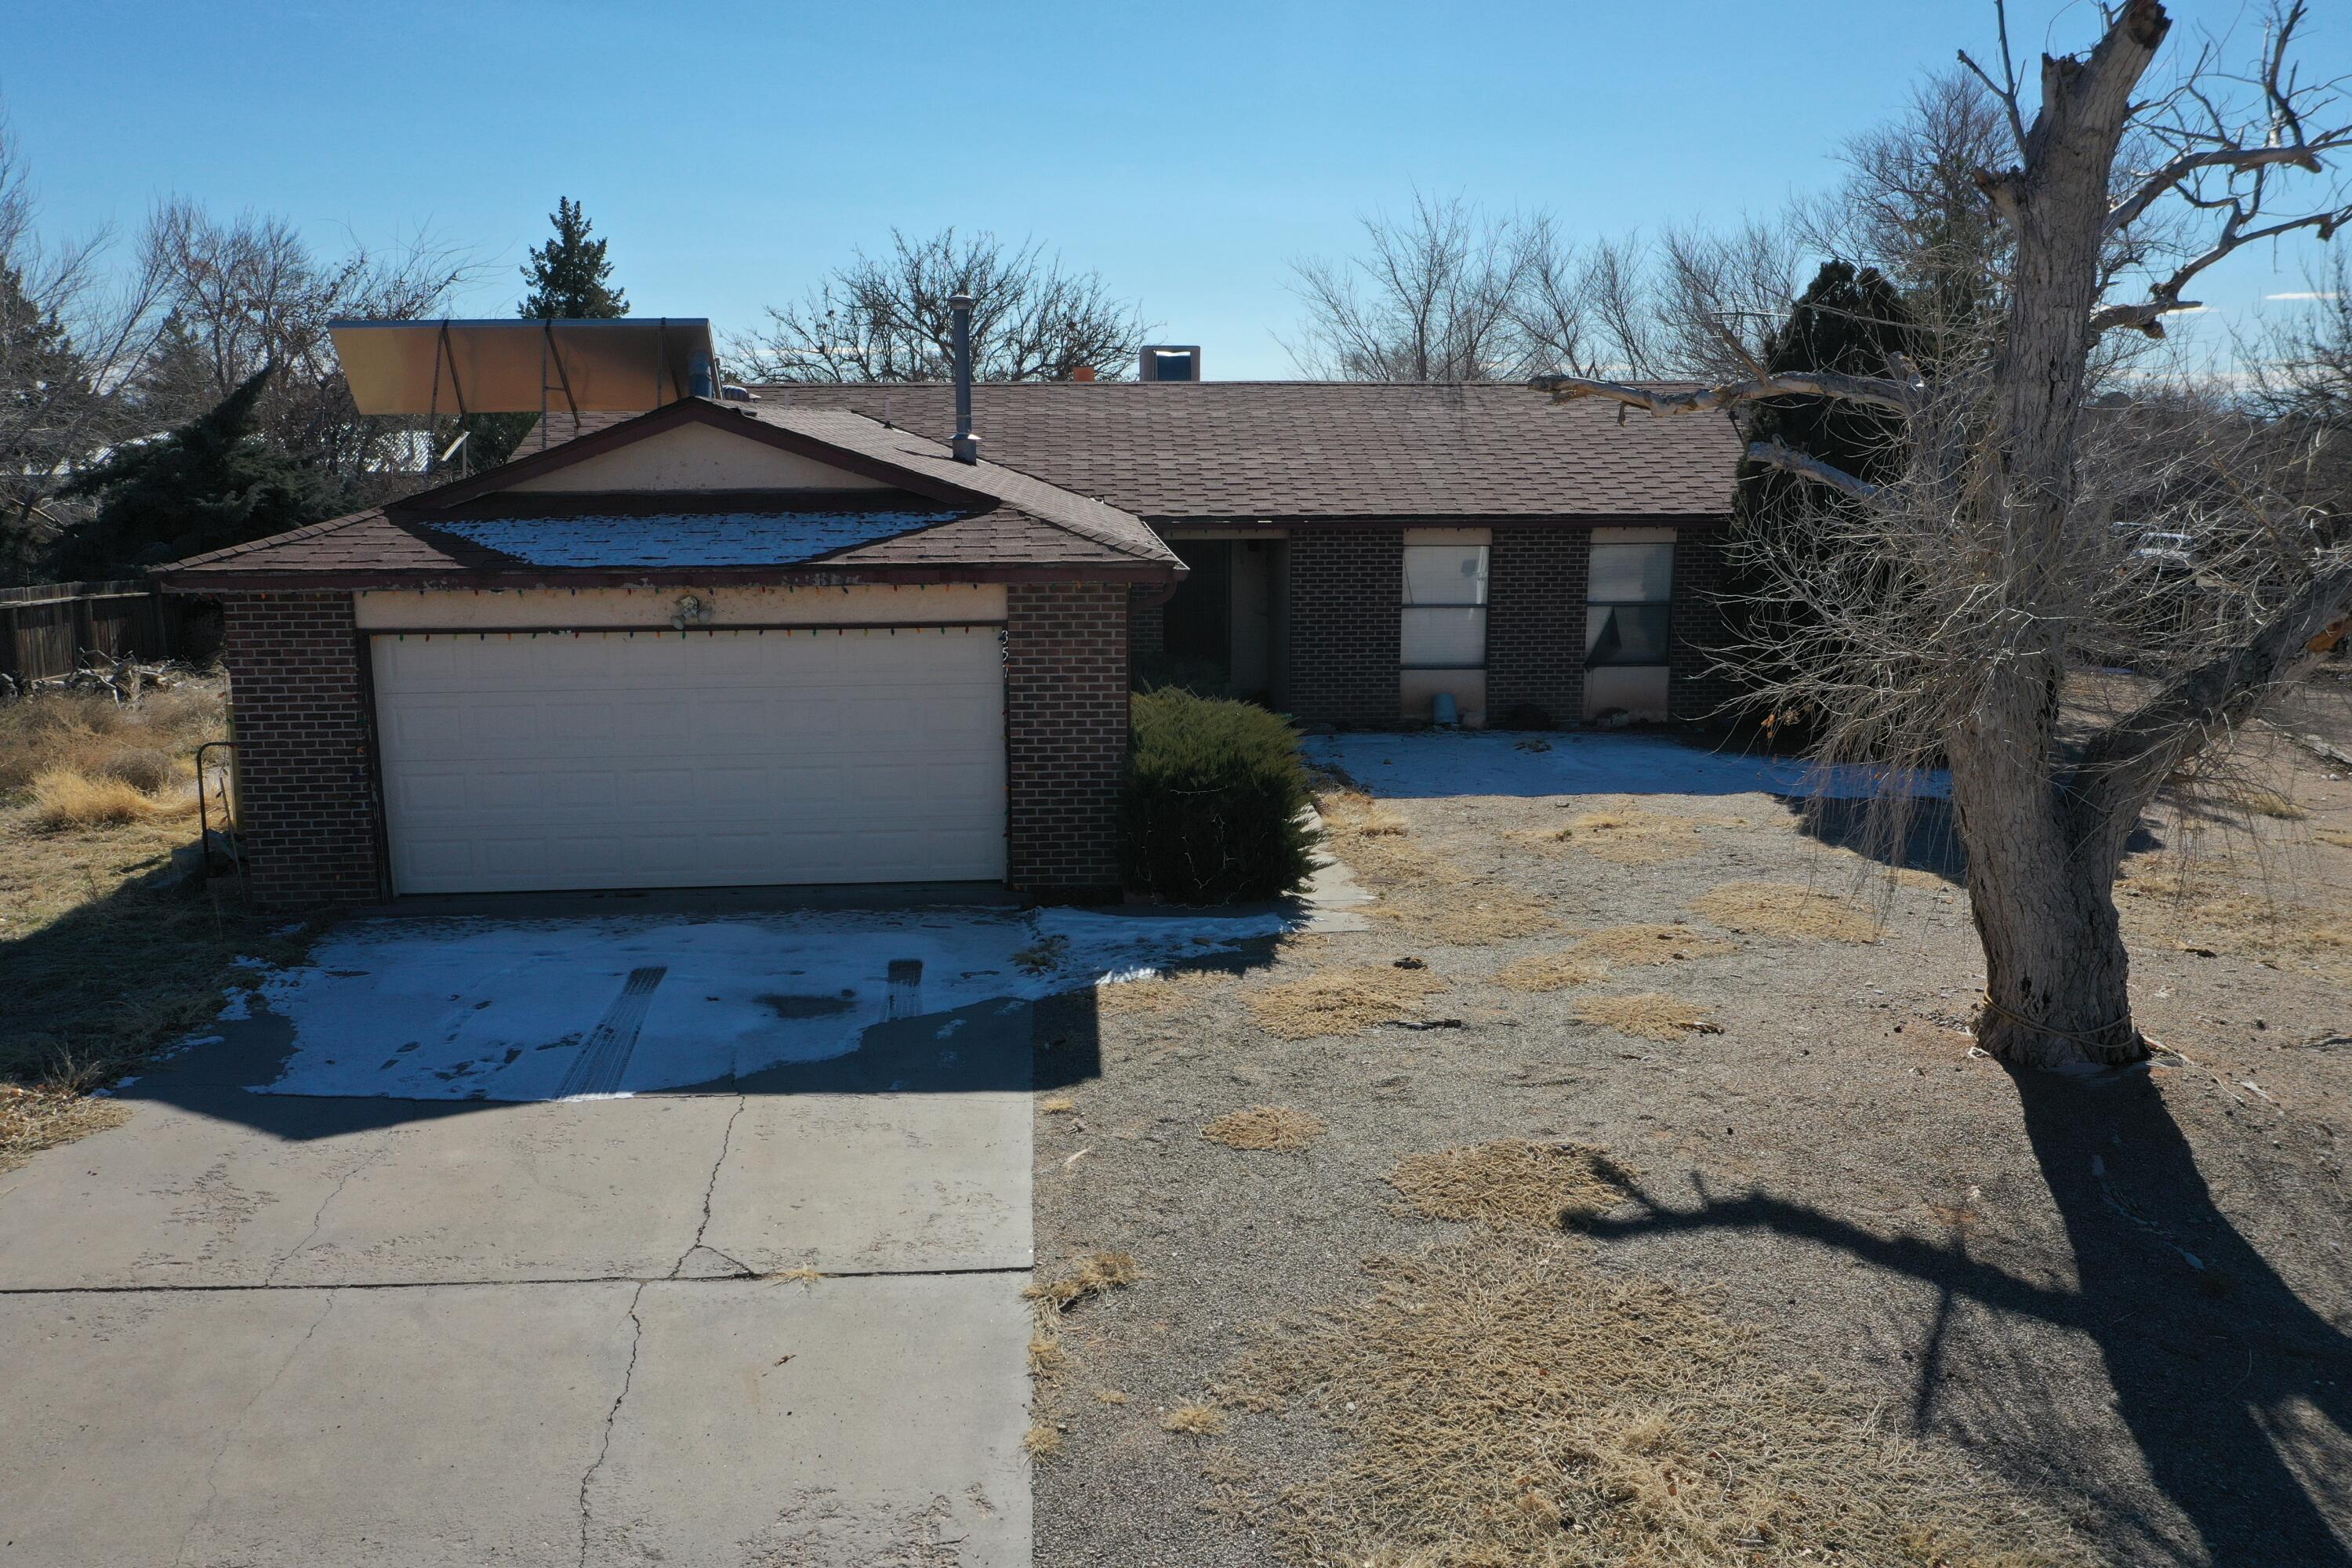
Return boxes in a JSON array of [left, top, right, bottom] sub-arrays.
[[1284, 524, 1404, 729]]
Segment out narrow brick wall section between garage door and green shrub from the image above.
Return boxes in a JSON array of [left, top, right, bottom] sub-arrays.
[[1004, 583, 1129, 900]]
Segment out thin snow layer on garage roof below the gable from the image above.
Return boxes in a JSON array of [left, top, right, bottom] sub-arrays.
[[426, 510, 960, 567]]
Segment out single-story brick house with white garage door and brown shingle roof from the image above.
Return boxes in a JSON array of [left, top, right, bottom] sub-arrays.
[[165, 381, 1738, 907]]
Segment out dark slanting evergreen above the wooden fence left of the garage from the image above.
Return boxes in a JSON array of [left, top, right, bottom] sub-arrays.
[[56, 367, 343, 579]]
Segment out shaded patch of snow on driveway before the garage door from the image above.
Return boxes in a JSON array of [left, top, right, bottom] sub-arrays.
[[223, 909, 1296, 1100]]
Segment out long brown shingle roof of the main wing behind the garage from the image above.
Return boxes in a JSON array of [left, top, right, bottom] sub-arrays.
[[548, 381, 1740, 520]]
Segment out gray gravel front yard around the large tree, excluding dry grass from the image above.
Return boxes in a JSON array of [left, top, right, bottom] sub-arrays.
[[1037, 681, 2352, 1568]]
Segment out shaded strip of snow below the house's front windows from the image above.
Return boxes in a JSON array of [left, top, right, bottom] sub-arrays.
[[1305, 731, 1952, 799]]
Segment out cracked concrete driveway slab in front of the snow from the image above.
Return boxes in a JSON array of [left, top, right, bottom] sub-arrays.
[[0, 912, 1030, 1568]]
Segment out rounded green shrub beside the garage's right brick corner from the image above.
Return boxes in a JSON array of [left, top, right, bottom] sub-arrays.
[[1122, 687, 1315, 902]]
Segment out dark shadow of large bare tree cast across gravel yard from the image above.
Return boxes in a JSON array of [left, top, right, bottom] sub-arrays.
[[1588, 1069, 2352, 1568]]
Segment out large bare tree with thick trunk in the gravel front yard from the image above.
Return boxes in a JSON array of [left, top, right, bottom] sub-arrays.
[[1538, 0, 2352, 1065]]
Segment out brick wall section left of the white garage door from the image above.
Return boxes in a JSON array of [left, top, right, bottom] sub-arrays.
[[221, 593, 383, 907]]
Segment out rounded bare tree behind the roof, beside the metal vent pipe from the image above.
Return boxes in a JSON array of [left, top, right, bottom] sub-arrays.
[[727, 228, 1145, 381]]
